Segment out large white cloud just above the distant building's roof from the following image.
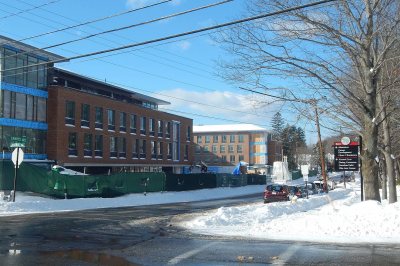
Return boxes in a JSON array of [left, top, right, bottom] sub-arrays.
[[155, 88, 277, 127]]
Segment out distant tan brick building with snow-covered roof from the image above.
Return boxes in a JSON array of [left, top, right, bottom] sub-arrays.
[[193, 124, 282, 172]]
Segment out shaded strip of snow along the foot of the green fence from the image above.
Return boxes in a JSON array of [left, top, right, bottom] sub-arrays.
[[0, 185, 265, 216]]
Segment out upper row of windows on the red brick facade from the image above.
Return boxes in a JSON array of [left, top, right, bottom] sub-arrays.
[[65, 101, 191, 141]]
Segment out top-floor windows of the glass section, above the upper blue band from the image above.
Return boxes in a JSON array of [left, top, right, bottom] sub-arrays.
[[0, 48, 47, 89]]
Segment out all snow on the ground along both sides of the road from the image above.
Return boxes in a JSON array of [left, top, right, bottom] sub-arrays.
[[0, 171, 400, 243]]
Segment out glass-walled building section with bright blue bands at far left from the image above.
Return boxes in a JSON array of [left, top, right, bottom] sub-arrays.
[[0, 36, 62, 159]]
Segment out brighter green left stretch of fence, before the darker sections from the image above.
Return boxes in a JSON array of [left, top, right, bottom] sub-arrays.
[[0, 161, 165, 198]]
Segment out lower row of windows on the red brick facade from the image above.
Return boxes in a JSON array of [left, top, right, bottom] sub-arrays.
[[68, 132, 189, 160]]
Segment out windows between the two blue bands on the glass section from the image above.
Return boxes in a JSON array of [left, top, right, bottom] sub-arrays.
[[0, 90, 47, 122]]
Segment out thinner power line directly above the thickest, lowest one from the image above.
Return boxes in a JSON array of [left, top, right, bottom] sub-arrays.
[[1, 0, 233, 60]]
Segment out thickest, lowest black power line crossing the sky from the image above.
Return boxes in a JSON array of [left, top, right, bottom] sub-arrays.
[[2, 0, 337, 70]]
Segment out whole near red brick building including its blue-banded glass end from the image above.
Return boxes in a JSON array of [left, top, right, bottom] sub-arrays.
[[0, 36, 193, 173]]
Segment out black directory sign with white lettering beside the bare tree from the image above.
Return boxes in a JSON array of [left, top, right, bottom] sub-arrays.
[[334, 141, 359, 171]]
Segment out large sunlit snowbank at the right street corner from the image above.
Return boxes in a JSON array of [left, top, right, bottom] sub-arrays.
[[182, 174, 400, 243]]
